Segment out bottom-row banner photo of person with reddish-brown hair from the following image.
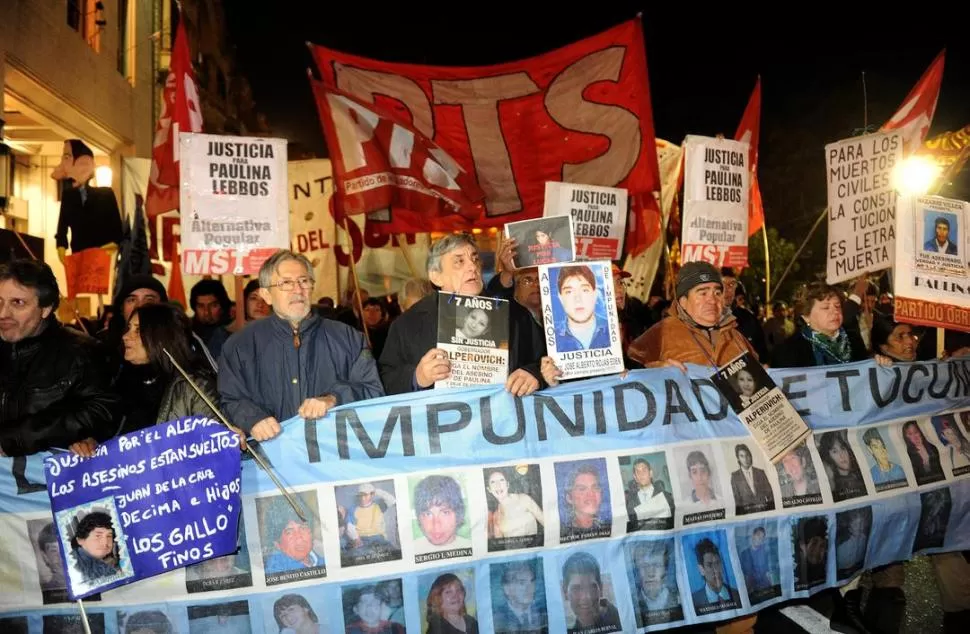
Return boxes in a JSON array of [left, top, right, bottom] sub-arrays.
[[418, 568, 478, 634]]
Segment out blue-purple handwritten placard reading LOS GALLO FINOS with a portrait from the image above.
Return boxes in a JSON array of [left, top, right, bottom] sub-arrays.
[[44, 417, 242, 599]]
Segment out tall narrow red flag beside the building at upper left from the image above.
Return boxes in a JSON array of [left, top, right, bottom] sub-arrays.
[[145, 22, 202, 221]]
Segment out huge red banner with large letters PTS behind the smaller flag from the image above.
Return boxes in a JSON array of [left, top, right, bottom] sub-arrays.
[[311, 19, 660, 253]]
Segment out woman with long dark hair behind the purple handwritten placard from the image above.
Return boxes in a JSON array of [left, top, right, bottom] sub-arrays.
[[71, 304, 218, 456]]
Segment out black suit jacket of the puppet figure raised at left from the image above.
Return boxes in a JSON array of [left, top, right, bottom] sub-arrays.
[[54, 187, 121, 253]]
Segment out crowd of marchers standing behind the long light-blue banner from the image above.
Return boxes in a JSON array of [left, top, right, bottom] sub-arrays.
[[0, 228, 970, 632]]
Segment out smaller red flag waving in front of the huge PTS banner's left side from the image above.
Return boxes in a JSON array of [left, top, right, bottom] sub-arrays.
[[310, 78, 485, 230]]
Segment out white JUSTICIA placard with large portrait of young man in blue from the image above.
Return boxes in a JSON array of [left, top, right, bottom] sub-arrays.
[[539, 262, 623, 379]]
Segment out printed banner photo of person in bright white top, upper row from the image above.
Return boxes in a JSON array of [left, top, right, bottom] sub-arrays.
[[484, 465, 545, 552]]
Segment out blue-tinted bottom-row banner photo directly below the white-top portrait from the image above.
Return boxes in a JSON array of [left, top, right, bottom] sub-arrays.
[[489, 558, 549, 634]]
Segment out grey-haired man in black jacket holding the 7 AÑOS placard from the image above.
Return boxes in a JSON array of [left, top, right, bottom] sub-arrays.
[[380, 233, 546, 396]]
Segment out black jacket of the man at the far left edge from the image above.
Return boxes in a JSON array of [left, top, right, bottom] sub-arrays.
[[0, 318, 120, 456]]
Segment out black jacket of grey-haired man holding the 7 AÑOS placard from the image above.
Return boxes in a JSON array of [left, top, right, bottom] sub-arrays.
[[379, 293, 546, 394]]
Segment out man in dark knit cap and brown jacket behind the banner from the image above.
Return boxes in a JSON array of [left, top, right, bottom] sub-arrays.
[[627, 262, 757, 371]]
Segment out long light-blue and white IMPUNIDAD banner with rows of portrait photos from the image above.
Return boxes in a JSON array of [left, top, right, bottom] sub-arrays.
[[0, 360, 970, 634]]
